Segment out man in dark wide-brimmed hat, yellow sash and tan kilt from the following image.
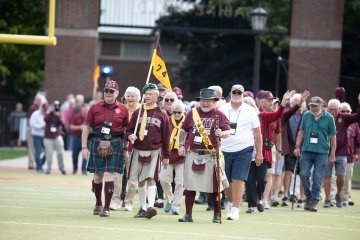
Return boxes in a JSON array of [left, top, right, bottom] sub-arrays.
[[179, 88, 230, 223]]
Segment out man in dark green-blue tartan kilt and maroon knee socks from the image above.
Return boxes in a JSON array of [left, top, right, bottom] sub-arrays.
[[81, 80, 129, 217]]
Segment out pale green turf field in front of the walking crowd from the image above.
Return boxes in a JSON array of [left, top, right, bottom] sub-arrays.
[[0, 169, 360, 240]]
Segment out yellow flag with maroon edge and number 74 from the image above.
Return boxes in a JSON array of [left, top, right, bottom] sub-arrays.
[[151, 39, 172, 91]]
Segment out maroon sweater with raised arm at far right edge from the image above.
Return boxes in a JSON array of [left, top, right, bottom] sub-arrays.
[[335, 105, 360, 156]]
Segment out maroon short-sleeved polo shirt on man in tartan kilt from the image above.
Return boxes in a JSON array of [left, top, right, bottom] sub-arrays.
[[84, 100, 129, 132]]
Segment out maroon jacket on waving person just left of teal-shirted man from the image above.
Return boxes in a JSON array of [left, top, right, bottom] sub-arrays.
[[281, 104, 301, 156]]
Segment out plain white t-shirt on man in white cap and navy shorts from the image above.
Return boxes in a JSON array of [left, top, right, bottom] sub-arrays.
[[219, 103, 260, 152]]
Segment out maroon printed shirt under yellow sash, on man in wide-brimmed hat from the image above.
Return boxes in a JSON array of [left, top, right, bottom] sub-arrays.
[[182, 107, 230, 149]]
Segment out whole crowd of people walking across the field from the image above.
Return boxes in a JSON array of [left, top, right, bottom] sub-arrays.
[[23, 80, 360, 223]]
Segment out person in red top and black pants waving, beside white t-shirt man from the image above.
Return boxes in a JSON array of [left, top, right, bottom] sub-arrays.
[[245, 91, 295, 213]]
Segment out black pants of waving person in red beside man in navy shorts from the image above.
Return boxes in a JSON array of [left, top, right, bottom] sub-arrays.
[[245, 161, 268, 207]]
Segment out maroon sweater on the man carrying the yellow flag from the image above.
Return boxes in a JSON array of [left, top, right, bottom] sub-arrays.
[[126, 107, 170, 158]]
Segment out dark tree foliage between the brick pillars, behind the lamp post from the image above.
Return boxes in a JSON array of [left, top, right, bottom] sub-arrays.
[[157, 0, 290, 94]]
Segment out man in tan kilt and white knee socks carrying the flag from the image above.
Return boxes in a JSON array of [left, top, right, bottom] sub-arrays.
[[126, 83, 170, 219]]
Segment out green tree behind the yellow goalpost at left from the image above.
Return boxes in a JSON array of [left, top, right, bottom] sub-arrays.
[[0, 0, 46, 105]]
